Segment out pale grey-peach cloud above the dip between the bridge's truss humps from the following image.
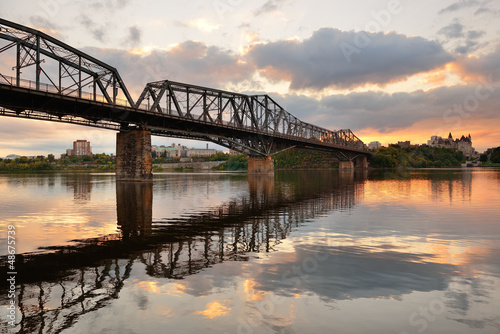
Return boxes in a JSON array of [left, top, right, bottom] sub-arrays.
[[85, 41, 254, 97]]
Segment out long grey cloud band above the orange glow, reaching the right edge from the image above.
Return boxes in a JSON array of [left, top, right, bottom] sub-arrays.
[[276, 82, 500, 133]]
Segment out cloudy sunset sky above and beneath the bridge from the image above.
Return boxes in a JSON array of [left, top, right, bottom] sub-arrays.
[[0, 0, 500, 157]]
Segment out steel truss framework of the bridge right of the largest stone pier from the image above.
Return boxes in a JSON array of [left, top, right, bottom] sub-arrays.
[[135, 80, 365, 156]]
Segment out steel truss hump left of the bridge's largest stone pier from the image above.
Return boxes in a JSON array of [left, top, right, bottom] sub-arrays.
[[0, 19, 134, 106]]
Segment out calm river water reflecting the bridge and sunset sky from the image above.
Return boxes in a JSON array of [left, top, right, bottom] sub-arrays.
[[0, 168, 500, 334]]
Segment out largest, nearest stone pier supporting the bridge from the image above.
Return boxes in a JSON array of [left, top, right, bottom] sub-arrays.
[[116, 130, 153, 181]]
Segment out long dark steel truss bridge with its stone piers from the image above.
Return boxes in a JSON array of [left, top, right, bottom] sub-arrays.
[[0, 19, 371, 180]]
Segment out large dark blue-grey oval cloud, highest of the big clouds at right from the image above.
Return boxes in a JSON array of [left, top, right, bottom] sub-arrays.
[[247, 28, 453, 90]]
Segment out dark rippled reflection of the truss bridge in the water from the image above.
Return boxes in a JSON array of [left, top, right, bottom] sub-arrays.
[[3, 172, 366, 333]]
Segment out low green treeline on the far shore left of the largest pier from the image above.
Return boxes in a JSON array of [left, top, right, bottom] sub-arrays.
[[0, 153, 115, 171]]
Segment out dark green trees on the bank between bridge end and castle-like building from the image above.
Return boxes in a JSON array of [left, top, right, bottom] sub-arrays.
[[370, 145, 465, 168]]
